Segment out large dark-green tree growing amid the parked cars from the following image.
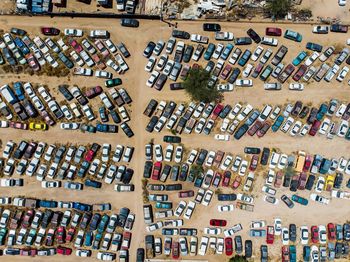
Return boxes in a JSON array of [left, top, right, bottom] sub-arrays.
[[182, 68, 222, 103]]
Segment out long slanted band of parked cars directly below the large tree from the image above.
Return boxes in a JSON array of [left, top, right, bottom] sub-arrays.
[[144, 99, 350, 140]]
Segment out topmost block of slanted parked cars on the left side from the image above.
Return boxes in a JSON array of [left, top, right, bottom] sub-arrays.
[[0, 27, 130, 78]]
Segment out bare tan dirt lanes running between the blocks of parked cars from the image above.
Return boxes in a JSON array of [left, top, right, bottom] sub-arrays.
[[0, 16, 350, 261]]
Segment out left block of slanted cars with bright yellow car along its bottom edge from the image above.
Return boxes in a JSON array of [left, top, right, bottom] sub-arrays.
[[0, 82, 132, 135]]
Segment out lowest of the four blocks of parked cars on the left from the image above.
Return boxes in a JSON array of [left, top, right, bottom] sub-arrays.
[[0, 202, 135, 257]]
